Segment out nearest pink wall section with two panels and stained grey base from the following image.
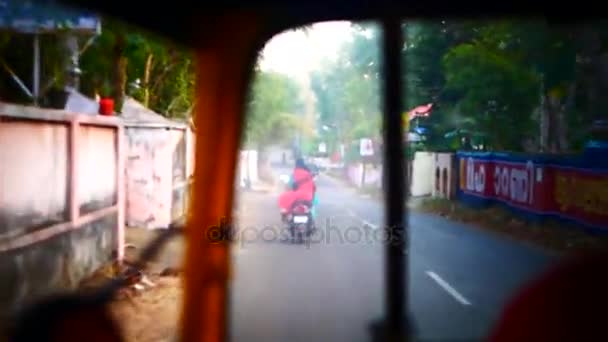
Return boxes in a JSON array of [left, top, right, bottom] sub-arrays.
[[0, 103, 124, 322]]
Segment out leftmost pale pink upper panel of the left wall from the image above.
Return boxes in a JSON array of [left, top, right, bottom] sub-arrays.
[[0, 118, 69, 234]]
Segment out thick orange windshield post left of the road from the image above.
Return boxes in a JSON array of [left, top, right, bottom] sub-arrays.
[[181, 14, 264, 341]]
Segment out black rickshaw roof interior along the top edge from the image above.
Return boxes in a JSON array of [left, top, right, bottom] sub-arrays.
[[61, 0, 602, 48]]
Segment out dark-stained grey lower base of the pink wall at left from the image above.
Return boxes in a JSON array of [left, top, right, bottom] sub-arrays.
[[0, 214, 118, 318]]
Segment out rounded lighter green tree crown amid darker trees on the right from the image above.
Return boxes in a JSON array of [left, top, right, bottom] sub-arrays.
[[444, 43, 538, 150]]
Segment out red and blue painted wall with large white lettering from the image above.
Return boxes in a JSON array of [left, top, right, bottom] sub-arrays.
[[457, 152, 608, 229]]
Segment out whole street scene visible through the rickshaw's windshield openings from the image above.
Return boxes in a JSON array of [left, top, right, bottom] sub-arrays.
[[0, 1, 608, 341]]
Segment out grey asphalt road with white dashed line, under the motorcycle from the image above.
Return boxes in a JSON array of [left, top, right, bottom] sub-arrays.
[[230, 176, 552, 341]]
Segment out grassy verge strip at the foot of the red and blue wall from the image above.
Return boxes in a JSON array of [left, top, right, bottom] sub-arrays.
[[418, 199, 608, 254]]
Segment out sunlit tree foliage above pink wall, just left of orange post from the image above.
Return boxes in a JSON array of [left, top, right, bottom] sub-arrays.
[[81, 20, 195, 118]]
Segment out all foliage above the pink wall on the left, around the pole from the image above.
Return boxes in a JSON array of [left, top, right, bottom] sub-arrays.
[[0, 18, 195, 118]]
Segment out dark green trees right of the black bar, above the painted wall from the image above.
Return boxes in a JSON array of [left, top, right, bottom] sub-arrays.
[[404, 20, 603, 152]]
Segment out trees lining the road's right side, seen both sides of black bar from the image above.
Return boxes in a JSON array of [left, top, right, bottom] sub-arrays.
[[311, 19, 608, 152]]
